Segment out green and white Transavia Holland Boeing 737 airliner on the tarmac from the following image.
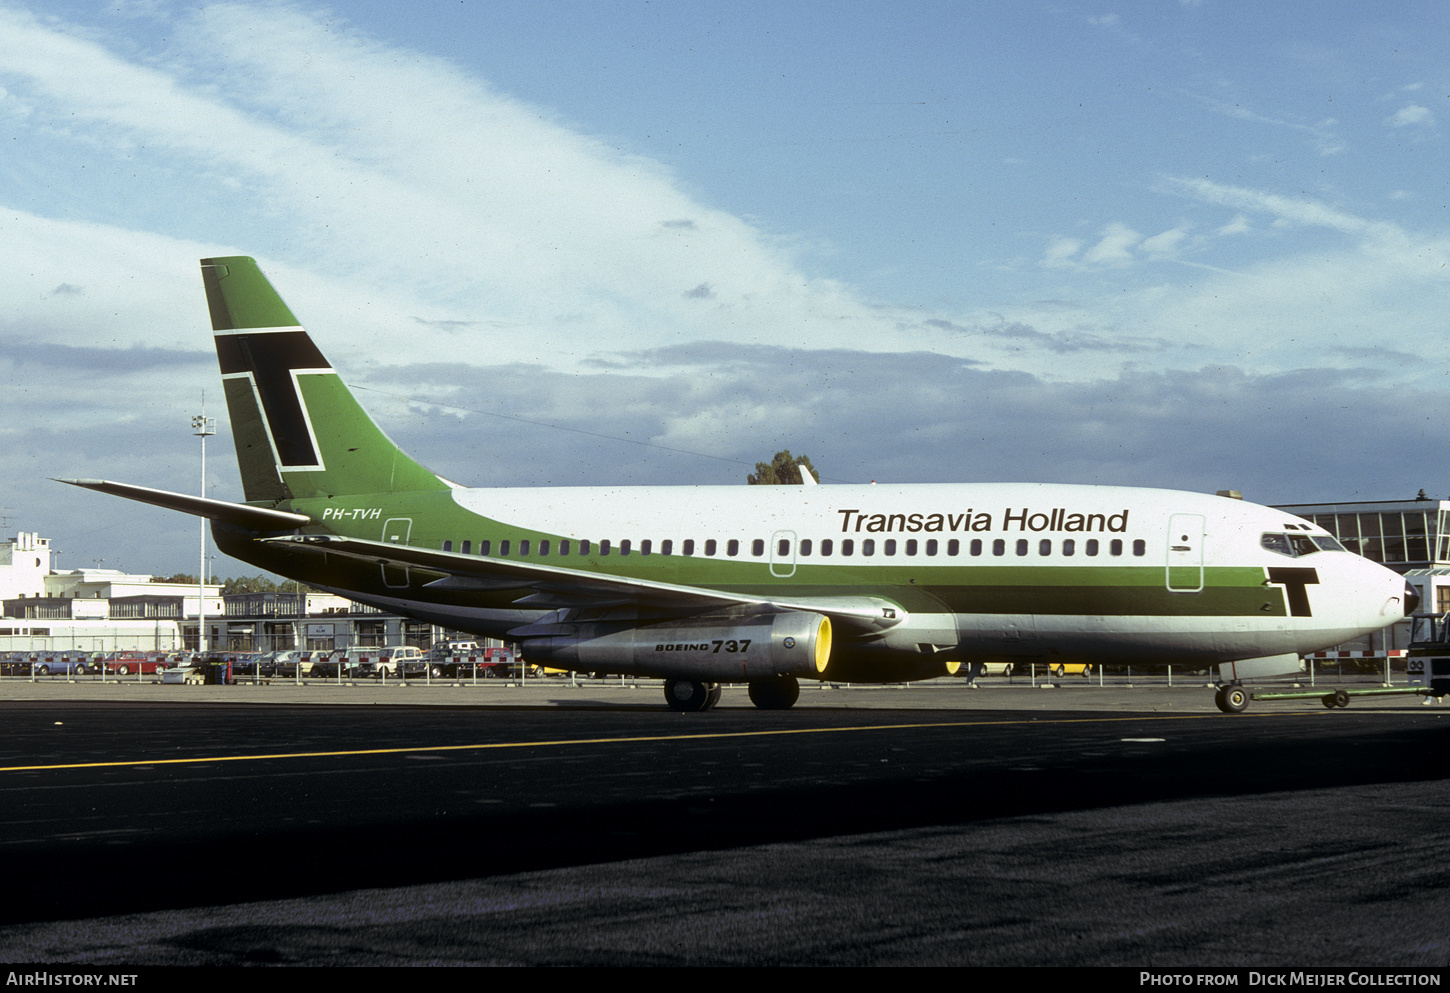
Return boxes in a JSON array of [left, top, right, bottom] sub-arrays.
[[64, 257, 1418, 712]]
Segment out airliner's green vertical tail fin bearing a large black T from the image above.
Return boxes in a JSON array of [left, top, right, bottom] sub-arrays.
[[202, 255, 448, 502]]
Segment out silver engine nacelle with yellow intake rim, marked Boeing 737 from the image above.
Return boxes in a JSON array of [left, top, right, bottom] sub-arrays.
[[523, 610, 831, 683]]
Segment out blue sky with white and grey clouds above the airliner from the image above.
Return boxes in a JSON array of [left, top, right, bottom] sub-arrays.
[[0, 0, 1450, 574]]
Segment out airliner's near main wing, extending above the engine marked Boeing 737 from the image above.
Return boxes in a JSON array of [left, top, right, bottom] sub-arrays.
[[262, 535, 906, 633]]
